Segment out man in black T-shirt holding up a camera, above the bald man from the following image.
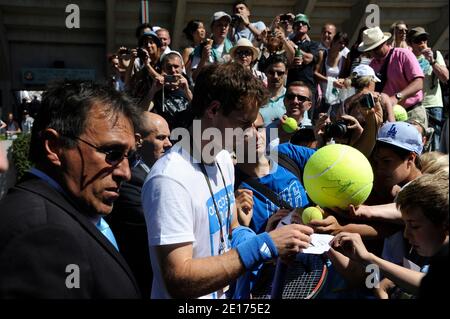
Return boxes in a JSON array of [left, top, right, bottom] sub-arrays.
[[141, 51, 192, 130]]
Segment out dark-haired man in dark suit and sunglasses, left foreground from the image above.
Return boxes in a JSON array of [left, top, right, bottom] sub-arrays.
[[0, 82, 140, 299]]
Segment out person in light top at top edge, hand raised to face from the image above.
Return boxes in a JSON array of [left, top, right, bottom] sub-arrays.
[[230, 1, 266, 46]]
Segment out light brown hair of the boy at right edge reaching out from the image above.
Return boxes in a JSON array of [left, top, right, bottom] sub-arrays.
[[395, 171, 448, 229]]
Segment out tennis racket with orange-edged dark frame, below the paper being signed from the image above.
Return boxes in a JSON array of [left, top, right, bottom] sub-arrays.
[[270, 253, 328, 299]]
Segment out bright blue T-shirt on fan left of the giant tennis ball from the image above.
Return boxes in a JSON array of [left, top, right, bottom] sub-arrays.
[[239, 143, 315, 234]]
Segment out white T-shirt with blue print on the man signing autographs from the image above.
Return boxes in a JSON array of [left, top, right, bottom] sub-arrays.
[[142, 143, 235, 299]]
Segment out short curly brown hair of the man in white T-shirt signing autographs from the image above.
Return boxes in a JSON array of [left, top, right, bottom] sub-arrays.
[[192, 62, 269, 118]]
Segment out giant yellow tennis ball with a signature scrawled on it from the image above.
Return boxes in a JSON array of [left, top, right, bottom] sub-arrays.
[[303, 144, 373, 210]]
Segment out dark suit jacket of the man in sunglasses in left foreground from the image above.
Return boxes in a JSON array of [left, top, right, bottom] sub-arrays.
[[0, 175, 140, 299]]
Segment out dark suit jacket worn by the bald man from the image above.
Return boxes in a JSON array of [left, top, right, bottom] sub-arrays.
[[107, 165, 153, 298]]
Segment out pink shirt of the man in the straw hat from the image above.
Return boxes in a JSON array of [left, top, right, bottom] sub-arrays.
[[370, 48, 424, 109]]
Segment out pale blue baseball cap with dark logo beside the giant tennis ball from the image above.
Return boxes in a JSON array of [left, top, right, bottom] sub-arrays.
[[377, 122, 423, 155]]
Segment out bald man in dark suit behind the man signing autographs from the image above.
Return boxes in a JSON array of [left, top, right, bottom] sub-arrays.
[[107, 112, 172, 298]]
